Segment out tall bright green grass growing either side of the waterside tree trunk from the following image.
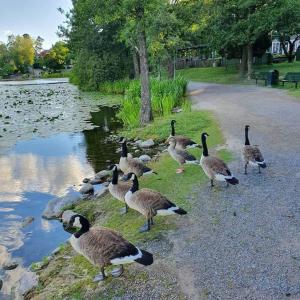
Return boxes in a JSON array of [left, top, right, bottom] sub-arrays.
[[118, 78, 187, 128]]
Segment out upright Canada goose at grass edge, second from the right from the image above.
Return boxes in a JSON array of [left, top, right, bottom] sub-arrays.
[[200, 132, 239, 187]]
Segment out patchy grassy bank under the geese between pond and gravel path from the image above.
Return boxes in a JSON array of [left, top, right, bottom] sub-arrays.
[[28, 111, 229, 299]]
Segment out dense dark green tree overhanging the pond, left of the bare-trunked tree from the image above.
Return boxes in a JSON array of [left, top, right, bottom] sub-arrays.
[[59, 0, 131, 90]]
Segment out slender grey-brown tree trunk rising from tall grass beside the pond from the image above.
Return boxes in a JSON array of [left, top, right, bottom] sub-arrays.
[[138, 28, 153, 125]]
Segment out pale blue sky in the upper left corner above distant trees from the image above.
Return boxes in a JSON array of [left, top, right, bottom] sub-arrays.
[[0, 0, 72, 49]]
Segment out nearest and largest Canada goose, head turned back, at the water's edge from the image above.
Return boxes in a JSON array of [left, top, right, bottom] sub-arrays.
[[68, 214, 153, 281]]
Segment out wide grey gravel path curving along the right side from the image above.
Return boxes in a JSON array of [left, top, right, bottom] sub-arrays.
[[171, 83, 300, 300]]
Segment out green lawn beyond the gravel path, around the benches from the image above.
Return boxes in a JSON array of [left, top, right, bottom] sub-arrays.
[[177, 62, 300, 97]]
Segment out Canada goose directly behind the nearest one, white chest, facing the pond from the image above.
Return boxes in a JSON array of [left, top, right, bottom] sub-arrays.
[[125, 173, 187, 232]]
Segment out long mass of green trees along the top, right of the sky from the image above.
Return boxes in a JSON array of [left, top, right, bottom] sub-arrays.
[[60, 0, 300, 124]]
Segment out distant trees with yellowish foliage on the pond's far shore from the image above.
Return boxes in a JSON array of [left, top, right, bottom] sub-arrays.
[[0, 34, 70, 78]]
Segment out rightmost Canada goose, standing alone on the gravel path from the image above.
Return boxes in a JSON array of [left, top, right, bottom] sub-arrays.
[[242, 125, 267, 174]]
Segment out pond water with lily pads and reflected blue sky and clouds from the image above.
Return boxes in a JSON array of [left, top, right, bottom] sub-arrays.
[[0, 83, 121, 298]]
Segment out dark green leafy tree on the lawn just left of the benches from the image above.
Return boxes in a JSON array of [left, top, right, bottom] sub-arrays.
[[208, 0, 283, 78]]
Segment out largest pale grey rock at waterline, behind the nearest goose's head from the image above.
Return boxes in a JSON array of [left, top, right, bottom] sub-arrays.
[[42, 191, 82, 219]]
